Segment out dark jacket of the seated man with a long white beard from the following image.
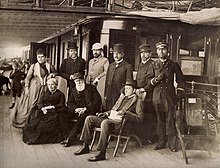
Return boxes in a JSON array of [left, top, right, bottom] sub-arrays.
[[67, 84, 102, 115]]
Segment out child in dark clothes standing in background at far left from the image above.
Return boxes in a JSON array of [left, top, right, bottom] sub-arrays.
[[9, 62, 25, 109]]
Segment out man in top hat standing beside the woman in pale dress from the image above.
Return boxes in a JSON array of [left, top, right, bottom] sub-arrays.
[[59, 42, 86, 96]]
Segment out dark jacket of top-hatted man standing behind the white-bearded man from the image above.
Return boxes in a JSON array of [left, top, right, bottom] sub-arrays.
[[59, 57, 86, 88]]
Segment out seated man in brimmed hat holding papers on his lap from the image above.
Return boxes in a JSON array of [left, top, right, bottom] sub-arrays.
[[74, 82, 143, 161]]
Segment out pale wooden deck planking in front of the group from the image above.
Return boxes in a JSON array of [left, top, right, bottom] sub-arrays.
[[0, 95, 220, 168]]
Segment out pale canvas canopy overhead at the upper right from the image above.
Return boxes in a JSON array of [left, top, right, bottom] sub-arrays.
[[127, 8, 220, 26]]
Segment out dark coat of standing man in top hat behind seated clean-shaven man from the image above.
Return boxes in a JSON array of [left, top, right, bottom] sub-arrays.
[[105, 61, 133, 110]]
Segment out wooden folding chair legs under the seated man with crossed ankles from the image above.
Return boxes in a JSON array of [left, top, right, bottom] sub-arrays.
[[90, 119, 143, 157]]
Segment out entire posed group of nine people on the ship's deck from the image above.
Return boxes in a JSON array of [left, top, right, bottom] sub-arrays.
[[9, 42, 185, 161]]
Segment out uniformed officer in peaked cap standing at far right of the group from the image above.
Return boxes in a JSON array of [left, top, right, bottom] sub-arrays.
[[146, 42, 185, 152]]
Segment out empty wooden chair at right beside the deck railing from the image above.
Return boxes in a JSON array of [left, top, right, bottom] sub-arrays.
[[176, 93, 215, 164]]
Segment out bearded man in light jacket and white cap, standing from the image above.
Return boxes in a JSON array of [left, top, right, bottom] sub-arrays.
[[86, 43, 109, 85]]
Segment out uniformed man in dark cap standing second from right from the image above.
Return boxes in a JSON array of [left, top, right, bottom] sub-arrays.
[[137, 44, 156, 143]]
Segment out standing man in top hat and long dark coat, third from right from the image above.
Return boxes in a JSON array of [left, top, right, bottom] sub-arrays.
[[104, 44, 133, 110]]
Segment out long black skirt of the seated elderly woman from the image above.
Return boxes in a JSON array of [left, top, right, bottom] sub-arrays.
[[23, 106, 62, 144]]
